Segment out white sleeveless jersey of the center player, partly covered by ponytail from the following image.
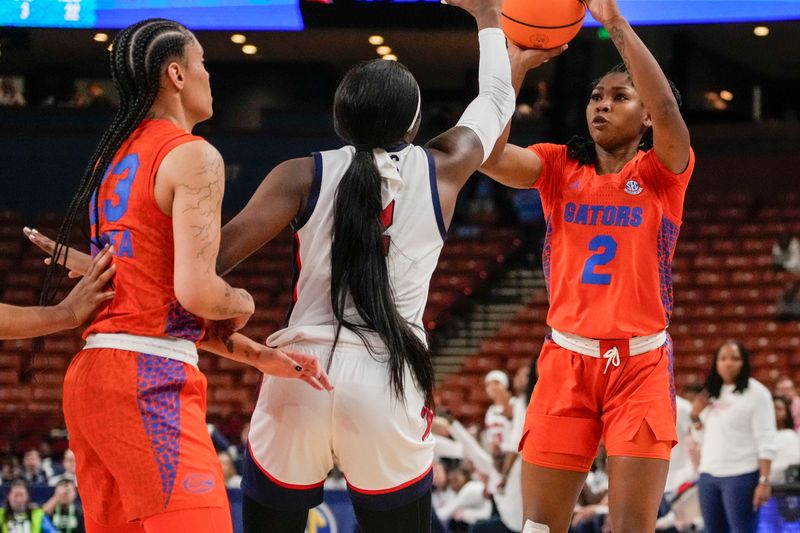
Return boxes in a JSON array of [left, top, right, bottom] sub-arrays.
[[267, 145, 446, 349]]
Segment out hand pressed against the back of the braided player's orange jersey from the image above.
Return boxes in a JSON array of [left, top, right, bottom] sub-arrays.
[[58, 245, 116, 328]]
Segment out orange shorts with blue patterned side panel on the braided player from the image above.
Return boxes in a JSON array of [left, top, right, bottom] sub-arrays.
[[64, 348, 228, 526]]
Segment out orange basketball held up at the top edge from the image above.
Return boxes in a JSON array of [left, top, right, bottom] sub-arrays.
[[501, 0, 586, 49]]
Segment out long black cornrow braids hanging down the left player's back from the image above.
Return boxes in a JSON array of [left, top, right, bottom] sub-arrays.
[[39, 19, 194, 305]]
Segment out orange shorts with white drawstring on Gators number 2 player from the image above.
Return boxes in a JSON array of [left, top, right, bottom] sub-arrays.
[[520, 338, 677, 472]]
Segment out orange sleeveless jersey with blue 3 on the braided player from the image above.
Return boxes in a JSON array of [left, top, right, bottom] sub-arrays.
[[84, 120, 205, 342]]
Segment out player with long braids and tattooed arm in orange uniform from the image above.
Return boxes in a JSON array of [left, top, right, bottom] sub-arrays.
[[38, 19, 327, 533]]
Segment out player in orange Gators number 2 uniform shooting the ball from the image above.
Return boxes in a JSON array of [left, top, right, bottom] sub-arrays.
[[482, 0, 694, 533]]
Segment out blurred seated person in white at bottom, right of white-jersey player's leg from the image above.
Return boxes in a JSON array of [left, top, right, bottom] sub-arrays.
[[436, 465, 492, 533]]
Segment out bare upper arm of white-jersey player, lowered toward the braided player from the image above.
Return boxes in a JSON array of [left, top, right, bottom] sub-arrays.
[[217, 157, 314, 275]]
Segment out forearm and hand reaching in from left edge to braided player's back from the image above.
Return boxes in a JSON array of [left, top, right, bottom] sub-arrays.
[[0, 243, 115, 339]]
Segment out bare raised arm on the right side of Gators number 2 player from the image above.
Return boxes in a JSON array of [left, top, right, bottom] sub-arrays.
[[586, 0, 689, 174]]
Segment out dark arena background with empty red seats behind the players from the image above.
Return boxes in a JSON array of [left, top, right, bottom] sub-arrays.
[[0, 0, 800, 533]]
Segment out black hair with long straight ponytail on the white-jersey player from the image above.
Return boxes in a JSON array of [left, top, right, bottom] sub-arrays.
[[331, 60, 434, 407]]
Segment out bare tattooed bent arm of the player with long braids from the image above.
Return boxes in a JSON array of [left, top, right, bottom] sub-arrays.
[[155, 141, 255, 329]]
